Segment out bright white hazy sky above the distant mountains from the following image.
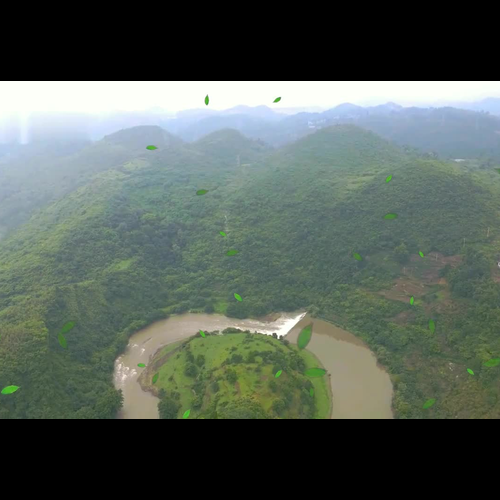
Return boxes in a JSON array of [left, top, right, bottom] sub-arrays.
[[0, 81, 500, 114]]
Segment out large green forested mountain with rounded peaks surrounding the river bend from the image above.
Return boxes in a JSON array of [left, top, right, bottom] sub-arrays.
[[0, 125, 500, 418]]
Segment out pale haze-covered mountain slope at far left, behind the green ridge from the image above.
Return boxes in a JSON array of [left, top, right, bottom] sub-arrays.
[[0, 126, 183, 236]]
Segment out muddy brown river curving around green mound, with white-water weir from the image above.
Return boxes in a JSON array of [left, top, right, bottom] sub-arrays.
[[114, 311, 393, 419]]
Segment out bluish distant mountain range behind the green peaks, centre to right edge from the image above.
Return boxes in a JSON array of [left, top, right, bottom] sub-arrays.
[[167, 103, 500, 160]]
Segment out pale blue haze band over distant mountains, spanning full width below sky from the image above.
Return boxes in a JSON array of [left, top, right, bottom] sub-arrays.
[[0, 98, 500, 158]]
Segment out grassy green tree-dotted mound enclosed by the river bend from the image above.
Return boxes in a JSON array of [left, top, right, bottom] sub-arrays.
[[139, 328, 332, 420]]
